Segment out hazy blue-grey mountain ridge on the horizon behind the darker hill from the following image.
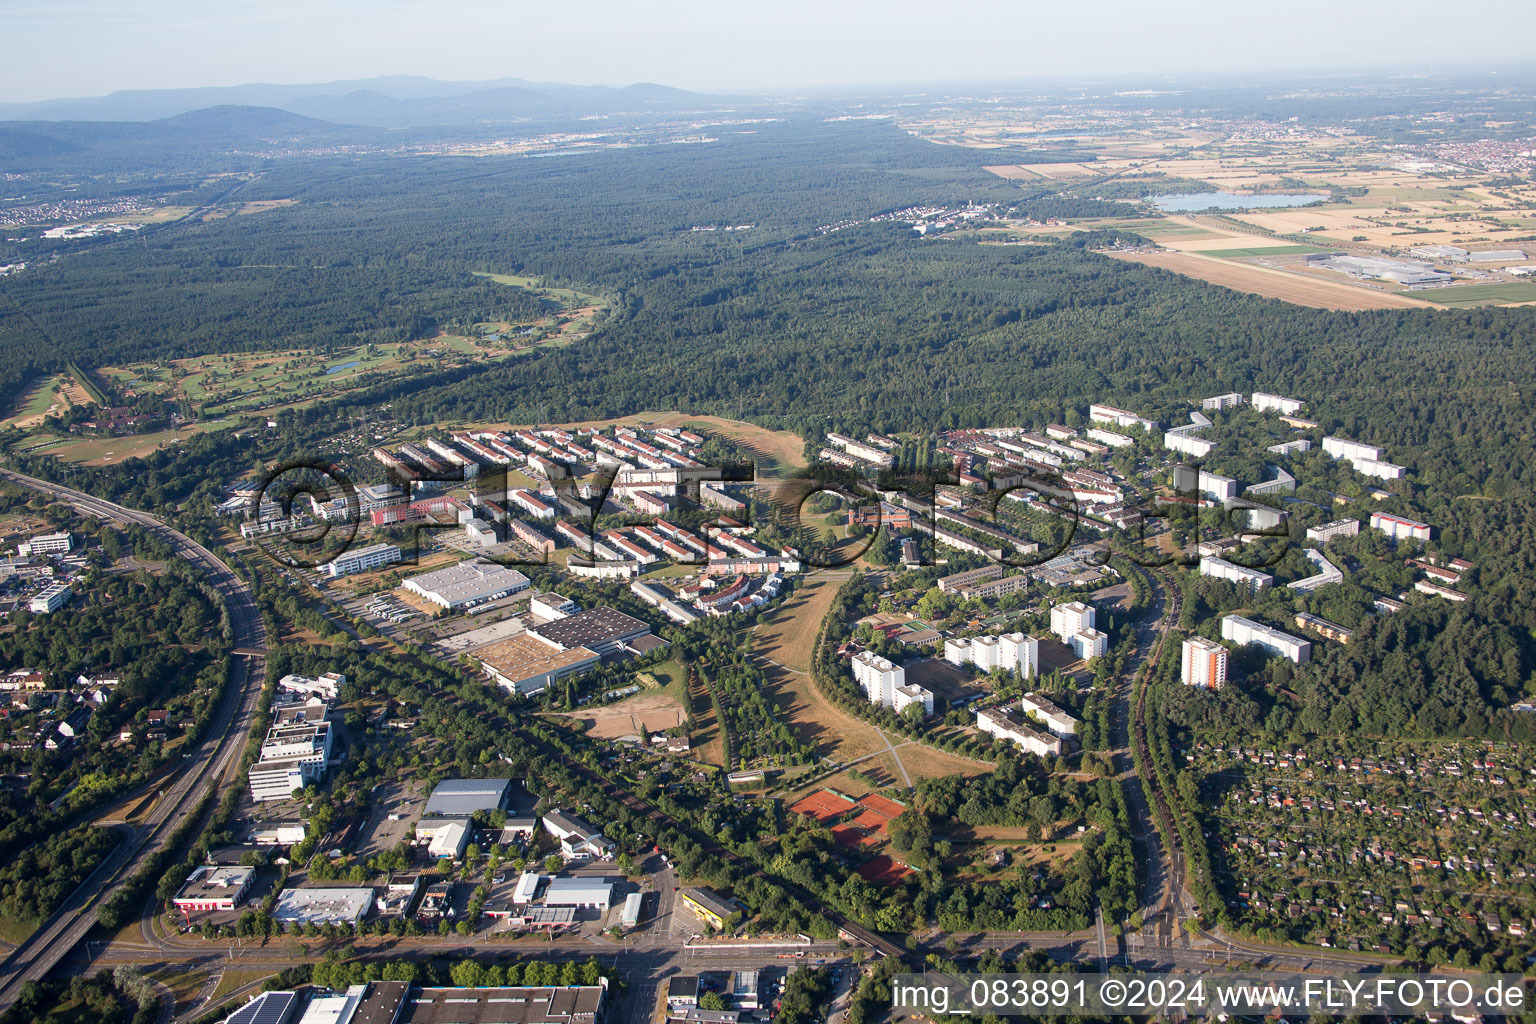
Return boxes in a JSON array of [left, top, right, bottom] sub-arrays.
[[0, 75, 743, 130]]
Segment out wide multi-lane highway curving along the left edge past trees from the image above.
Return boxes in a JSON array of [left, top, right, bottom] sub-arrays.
[[0, 470, 266, 1013]]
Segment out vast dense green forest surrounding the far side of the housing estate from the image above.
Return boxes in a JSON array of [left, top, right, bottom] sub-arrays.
[[0, 112, 1536, 734]]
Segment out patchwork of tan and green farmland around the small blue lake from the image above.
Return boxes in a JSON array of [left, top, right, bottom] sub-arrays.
[[927, 115, 1536, 310]]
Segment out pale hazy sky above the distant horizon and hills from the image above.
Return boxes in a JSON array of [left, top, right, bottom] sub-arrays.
[[9, 0, 1536, 101]]
